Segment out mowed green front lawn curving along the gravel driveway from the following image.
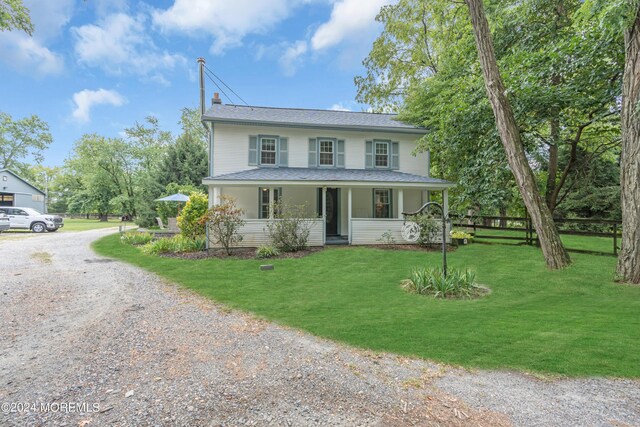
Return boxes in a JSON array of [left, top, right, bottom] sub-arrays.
[[94, 235, 640, 377]]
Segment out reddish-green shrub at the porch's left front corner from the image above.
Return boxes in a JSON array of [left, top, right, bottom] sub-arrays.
[[200, 195, 245, 255]]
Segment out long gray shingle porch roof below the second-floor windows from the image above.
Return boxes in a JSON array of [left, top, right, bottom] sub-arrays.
[[205, 168, 453, 186]]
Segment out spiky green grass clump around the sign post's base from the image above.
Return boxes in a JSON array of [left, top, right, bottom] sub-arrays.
[[402, 267, 487, 299]]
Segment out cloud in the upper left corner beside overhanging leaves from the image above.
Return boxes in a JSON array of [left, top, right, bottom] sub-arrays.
[[0, 0, 74, 75]]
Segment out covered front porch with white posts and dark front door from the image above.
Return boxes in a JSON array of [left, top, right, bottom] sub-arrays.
[[204, 168, 452, 247]]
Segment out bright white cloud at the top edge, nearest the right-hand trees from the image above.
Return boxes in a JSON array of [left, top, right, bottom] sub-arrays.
[[311, 0, 395, 50]]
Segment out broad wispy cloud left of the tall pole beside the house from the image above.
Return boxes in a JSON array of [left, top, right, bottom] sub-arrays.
[[72, 13, 186, 84]]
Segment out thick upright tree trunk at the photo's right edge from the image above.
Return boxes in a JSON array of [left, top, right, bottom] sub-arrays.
[[617, 8, 640, 283]]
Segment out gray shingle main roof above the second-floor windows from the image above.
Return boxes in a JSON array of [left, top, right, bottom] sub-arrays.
[[203, 104, 425, 134]]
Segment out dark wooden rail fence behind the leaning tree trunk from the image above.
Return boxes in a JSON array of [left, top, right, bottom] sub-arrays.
[[453, 216, 622, 256]]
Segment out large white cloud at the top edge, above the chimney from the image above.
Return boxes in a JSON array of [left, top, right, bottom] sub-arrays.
[[153, 0, 309, 54]]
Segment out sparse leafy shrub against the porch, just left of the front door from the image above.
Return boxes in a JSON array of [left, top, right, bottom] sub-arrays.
[[267, 202, 311, 252]]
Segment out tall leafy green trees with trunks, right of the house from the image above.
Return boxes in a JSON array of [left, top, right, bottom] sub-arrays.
[[355, 0, 640, 283]]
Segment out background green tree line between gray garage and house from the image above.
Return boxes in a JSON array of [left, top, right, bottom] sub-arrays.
[[0, 108, 207, 226]]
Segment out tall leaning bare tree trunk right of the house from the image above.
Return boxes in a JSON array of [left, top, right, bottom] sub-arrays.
[[465, 0, 571, 269]]
